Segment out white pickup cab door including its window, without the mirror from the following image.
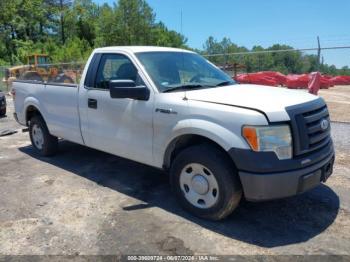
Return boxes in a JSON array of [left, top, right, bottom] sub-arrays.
[[79, 53, 153, 164]]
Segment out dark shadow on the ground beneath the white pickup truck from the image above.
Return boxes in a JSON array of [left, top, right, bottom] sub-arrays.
[[20, 141, 339, 247]]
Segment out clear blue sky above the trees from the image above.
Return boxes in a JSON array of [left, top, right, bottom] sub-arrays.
[[94, 0, 350, 67]]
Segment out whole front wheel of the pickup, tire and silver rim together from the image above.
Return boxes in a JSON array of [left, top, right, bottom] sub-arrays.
[[170, 144, 242, 220]]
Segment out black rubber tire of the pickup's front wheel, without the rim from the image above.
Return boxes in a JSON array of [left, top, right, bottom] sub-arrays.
[[170, 144, 242, 220]]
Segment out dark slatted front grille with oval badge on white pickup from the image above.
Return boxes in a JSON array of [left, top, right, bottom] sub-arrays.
[[286, 99, 331, 155]]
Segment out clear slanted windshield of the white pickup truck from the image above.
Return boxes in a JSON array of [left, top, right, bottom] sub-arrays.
[[136, 52, 235, 92]]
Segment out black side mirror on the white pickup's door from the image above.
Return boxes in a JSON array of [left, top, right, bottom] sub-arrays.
[[108, 80, 150, 101]]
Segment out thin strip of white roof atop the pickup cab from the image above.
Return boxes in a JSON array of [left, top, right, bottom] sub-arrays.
[[95, 46, 193, 53]]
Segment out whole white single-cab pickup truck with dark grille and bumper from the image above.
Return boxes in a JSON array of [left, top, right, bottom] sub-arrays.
[[12, 47, 334, 220]]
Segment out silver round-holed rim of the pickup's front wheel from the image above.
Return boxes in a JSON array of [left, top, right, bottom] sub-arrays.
[[180, 163, 219, 209]]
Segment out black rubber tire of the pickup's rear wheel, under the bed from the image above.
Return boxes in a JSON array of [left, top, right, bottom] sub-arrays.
[[29, 116, 58, 156]]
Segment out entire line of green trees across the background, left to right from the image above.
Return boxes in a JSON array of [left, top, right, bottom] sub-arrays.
[[0, 0, 350, 75]]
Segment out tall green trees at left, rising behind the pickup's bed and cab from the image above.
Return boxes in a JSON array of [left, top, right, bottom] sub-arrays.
[[0, 0, 186, 64]]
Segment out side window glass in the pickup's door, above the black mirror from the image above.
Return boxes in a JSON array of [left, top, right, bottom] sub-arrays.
[[95, 54, 143, 89]]
